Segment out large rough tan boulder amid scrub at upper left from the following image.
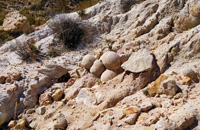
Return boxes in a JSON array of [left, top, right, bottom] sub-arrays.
[[3, 11, 30, 32]]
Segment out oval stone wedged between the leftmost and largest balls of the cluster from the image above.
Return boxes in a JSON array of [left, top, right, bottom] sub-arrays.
[[90, 60, 105, 77]]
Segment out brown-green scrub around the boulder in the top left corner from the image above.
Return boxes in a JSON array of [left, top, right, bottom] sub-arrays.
[[0, 0, 100, 46]]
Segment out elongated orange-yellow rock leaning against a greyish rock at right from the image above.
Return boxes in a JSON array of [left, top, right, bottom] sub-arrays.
[[148, 75, 168, 96]]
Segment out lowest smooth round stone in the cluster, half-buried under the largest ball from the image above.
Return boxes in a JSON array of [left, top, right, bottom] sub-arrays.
[[101, 69, 117, 81]]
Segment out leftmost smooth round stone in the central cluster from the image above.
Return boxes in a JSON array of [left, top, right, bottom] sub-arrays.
[[81, 55, 96, 69]]
